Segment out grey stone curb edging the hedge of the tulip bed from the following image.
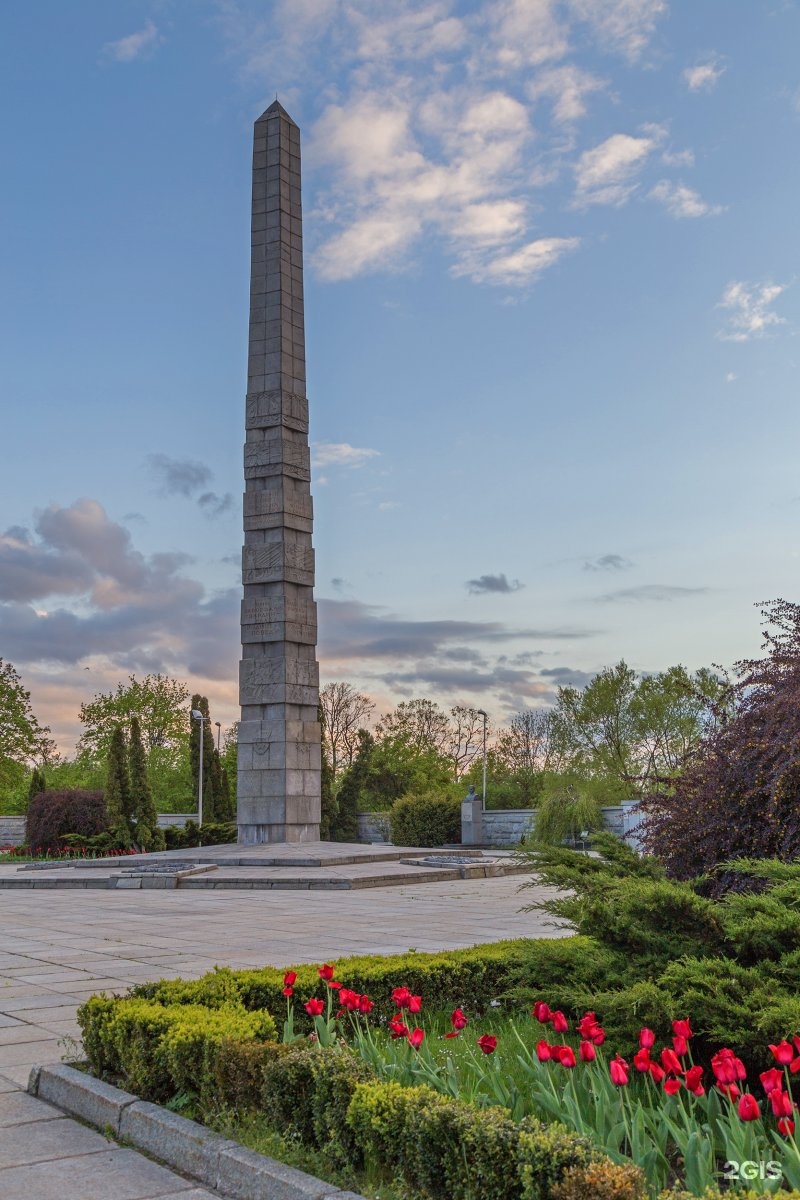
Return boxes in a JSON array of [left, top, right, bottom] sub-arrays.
[[28, 1063, 363, 1200]]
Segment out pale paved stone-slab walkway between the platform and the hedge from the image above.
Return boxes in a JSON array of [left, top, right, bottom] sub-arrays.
[[0, 876, 558, 1200]]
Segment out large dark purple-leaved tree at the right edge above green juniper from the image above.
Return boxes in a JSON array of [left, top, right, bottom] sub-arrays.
[[642, 600, 800, 878]]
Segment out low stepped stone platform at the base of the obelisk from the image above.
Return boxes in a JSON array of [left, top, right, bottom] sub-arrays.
[[0, 842, 521, 892]]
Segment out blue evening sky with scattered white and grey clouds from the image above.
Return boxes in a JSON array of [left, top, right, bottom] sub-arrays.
[[0, 0, 800, 752]]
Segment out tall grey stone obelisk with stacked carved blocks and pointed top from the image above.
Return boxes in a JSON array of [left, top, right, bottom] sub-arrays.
[[236, 100, 320, 844]]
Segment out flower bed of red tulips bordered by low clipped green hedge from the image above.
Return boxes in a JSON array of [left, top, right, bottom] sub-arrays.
[[79, 964, 800, 1200]]
